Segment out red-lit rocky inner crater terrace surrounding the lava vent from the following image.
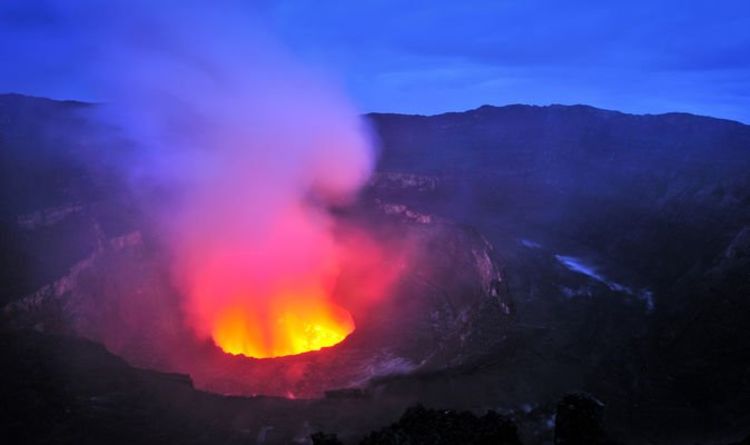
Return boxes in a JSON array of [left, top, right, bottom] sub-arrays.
[[6, 168, 512, 398]]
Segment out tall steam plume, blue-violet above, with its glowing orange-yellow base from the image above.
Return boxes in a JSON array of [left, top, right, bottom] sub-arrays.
[[86, 3, 373, 357]]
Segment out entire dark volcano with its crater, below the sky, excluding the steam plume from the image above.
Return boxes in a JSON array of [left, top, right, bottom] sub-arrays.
[[0, 96, 750, 444]]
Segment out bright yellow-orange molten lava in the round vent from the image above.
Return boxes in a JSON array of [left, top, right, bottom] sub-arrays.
[[212, 294, 354, 358]]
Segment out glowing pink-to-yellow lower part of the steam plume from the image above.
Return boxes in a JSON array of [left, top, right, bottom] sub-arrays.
[[181, 206, 368, 358]]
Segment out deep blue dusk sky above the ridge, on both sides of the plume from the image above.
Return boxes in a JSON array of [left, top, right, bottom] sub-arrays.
[[0, 0, 750, 123]]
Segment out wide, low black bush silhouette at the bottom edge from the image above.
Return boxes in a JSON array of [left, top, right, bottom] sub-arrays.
[[361, 405, 521, 445]]
